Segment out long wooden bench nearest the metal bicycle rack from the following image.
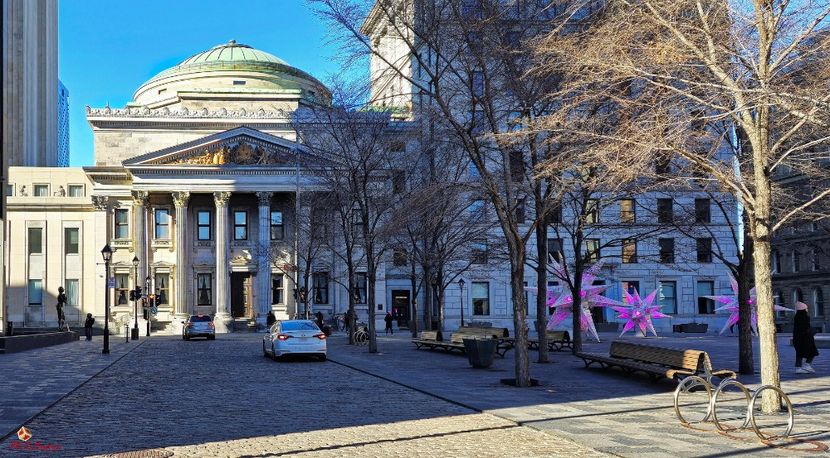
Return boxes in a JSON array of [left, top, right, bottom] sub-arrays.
[[577, 340, 735, 382]]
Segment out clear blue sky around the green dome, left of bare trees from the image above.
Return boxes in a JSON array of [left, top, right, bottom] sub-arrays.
[[58, 0, 352, 166]]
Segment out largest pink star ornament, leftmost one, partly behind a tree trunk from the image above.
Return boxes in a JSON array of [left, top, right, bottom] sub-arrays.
[[526, 261, 620, 342]]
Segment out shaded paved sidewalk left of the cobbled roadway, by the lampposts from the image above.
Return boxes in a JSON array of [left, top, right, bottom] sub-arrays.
[[0, 336, 146, 442]]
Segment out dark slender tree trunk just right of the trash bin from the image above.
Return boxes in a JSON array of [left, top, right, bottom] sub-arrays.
[[510, 241, 530, 387]]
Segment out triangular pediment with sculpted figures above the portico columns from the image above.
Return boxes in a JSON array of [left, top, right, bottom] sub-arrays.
[[124, 126, 308, 168]]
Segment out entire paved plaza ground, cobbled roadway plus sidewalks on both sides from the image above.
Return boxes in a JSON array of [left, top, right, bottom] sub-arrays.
[[0, 334, 830, 457]]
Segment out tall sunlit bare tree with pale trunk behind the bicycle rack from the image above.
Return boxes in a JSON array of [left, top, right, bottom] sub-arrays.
[[538, 0, 830, 412]]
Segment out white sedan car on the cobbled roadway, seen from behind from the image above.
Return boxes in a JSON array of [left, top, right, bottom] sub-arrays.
[[262, 320, 326, 361]]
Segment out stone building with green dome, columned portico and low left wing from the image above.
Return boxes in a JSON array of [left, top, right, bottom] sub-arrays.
[[7, 40, 384, 335]]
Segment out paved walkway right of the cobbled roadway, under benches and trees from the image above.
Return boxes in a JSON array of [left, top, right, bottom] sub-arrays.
[[329, 333, 830, 457]]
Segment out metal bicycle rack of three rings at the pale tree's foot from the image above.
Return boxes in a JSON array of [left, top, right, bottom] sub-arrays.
[[674, 375, 794, 442]]
